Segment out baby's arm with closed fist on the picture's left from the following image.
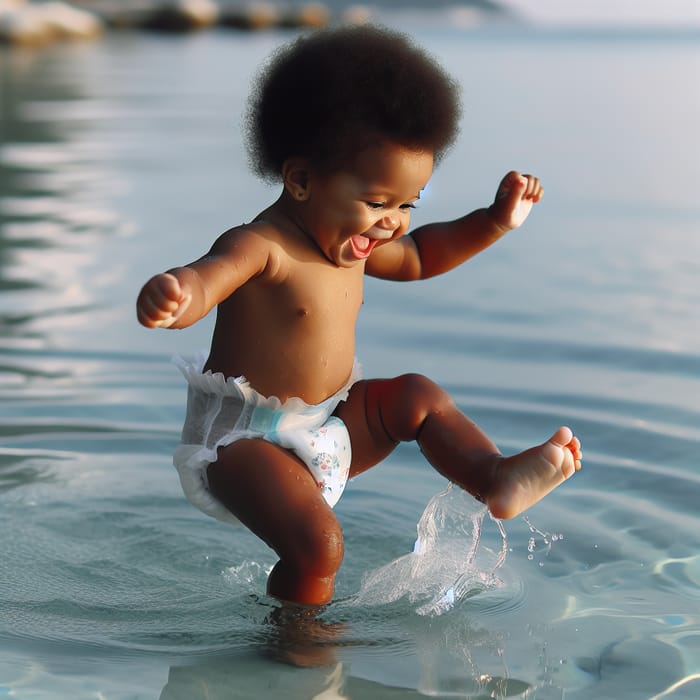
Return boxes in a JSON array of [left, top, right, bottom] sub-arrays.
[[136, 229, 270, 328]]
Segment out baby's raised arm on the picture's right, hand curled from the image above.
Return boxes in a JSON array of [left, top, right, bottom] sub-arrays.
[[366, 171, 543, 281]]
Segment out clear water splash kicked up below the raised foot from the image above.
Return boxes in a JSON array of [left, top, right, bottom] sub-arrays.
[[354, 484, 507, 615]]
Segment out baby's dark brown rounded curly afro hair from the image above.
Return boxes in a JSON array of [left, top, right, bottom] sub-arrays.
[[245, 26, 461, 182]]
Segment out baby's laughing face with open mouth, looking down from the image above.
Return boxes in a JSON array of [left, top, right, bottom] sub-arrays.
[[304, 143, 433, 267]]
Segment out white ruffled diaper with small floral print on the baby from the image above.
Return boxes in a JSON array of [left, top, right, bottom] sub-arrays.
[[173, 353, 360, 522]]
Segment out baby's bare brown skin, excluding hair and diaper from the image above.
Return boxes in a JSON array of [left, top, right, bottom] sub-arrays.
[[137, 142, 581, 604]]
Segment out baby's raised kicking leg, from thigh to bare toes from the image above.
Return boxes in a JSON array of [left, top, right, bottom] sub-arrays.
[[337, 374, 581, 518]]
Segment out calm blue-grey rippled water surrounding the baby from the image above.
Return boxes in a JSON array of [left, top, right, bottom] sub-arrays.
[[0, 19, 700, 700]]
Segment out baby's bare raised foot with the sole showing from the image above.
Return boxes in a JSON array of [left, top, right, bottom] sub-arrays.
[[484, 427, 581, 519]]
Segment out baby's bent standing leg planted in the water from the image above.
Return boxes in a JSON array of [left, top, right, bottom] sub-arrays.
[[207, 440, 343, 605]]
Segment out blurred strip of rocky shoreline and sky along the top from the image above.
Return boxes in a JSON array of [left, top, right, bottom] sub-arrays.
[[0, 0, 700, 47]]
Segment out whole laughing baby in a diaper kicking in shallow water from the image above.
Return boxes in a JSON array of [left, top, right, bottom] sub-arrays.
[[137, 26, 581, 604]]
